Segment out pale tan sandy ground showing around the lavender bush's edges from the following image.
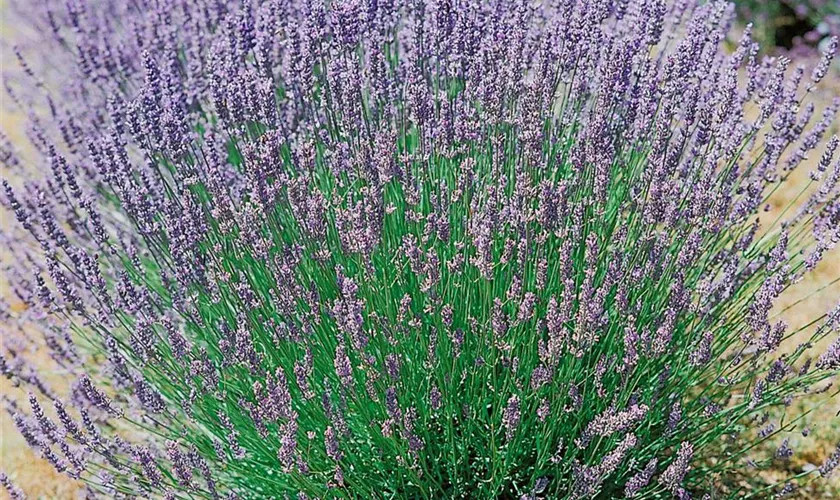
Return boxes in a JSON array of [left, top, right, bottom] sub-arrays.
[[0, 6, 840, 499]]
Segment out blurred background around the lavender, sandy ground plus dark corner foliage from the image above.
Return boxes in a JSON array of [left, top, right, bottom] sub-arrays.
[[0, 0, 840, 499]]
